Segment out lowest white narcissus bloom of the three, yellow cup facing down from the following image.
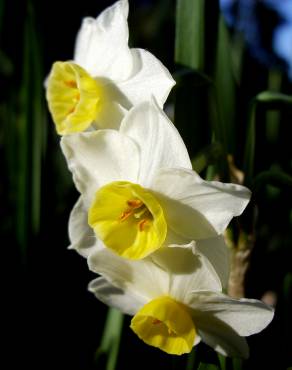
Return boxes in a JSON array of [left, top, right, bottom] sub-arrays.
[[88, 247, 274, 358]]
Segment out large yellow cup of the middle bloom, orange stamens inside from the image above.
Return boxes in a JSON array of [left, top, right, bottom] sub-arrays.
[[88, 181, 167, 259]]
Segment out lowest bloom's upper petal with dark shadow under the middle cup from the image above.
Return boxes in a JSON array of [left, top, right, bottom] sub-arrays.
[[151, 243, 222, 304]]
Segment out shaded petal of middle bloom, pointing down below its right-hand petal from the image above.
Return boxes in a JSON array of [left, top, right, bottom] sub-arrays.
[[196, 236, 230, 289]]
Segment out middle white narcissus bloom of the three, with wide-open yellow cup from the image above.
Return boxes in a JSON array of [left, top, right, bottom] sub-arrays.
[[61, 100, 250, 284]]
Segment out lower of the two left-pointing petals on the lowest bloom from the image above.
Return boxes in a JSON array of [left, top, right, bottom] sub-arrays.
[[88, 277, 147, 315]]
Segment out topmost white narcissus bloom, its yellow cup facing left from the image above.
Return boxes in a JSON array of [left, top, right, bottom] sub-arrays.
[[47, 0, 174, 135]]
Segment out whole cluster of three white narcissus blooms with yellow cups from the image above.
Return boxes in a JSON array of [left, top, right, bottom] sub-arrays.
[[47, 0, 273, 357]]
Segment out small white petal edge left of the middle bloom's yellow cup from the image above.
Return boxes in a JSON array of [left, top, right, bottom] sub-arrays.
[[69, 197, 97, 258]]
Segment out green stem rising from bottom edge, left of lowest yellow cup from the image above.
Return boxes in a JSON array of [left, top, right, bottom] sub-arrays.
[[95, 308, 124, 370]]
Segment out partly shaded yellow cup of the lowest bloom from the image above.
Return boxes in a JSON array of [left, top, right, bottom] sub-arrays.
[[131, 296, 196, 355]]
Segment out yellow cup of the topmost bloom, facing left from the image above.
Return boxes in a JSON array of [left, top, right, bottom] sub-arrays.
[[47, 62, 102, 135]]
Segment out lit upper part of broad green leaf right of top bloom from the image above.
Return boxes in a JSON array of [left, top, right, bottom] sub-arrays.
[[175, 0, 205, 69]]
